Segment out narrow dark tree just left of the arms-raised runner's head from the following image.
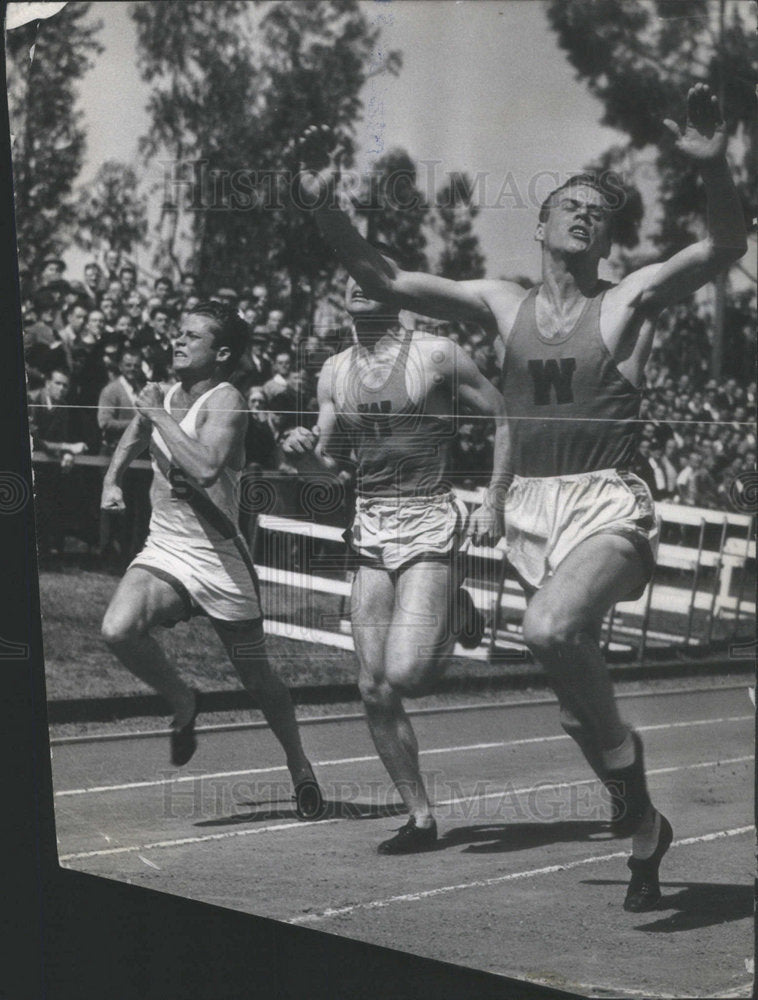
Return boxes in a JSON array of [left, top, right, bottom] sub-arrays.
[[434, 173, 485, 280]]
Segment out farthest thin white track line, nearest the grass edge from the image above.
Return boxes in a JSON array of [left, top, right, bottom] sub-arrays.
[[50, 684, 750, 747]]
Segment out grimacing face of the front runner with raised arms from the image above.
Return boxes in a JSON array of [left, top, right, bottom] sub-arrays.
[[537, 185, 610, 260]]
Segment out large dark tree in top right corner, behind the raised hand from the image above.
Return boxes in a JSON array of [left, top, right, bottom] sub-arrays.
[[547, 0, 758, 375]]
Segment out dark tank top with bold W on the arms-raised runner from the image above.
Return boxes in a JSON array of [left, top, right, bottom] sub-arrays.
[[501, 283, 641, 477]]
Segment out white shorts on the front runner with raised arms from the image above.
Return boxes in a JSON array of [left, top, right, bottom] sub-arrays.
[[505, 469, 660, 600]]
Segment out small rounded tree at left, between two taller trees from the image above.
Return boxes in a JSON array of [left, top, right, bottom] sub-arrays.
[[74, 160, 147, 254]]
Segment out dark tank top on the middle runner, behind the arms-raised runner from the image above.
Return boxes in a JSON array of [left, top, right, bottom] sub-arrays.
[[337, 330, 453, 497]]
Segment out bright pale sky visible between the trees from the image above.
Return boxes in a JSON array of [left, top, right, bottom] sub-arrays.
[[60, 0, 619, 277]]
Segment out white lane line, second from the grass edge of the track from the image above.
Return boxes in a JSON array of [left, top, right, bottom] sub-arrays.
[[55, 715, 754, 798]]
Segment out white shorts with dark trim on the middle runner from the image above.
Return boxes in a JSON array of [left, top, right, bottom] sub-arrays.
[[346, 492, 468, 573]]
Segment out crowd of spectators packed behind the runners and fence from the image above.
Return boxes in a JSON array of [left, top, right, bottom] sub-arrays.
[[22, 251, 756, 554]]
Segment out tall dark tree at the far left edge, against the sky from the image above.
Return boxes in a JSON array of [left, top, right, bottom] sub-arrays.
[[6, 3, 102, 273]]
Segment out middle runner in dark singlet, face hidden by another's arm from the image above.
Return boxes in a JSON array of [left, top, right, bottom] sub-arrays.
[[282, 270, 508, 854]]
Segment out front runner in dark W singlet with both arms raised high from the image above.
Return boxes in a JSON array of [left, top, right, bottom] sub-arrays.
[[300, 84, 747, 911]]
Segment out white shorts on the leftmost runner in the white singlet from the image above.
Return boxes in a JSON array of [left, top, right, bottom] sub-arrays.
[[128, 531, 262, 624]]
